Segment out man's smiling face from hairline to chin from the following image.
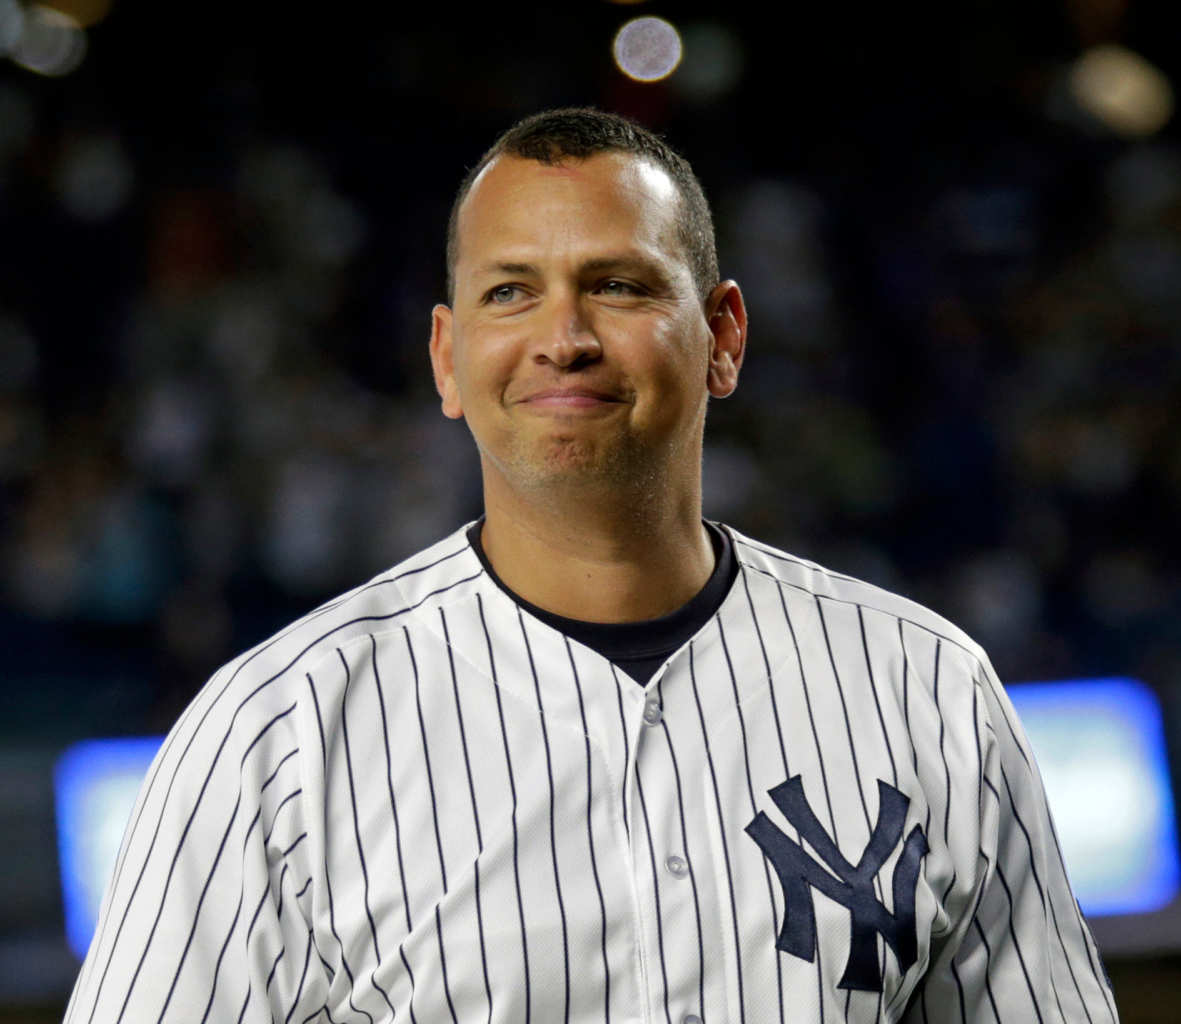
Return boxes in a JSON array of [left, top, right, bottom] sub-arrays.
[[431, 154, 740, 500]]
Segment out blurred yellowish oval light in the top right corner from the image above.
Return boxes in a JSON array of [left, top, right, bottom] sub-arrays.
[[1070, 43, 1174, 138]]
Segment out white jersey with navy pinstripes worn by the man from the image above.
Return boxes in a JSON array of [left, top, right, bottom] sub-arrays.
[[66, 527, 1116, 1024]]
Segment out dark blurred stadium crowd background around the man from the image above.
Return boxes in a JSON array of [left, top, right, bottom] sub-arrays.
[[0, 0, 1181, 1022]]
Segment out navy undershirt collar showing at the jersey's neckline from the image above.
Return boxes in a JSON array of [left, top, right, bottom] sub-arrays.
[[468, 516, 738, 686]]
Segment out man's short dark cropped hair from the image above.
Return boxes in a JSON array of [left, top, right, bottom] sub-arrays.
[[446, 107, 718, 302]]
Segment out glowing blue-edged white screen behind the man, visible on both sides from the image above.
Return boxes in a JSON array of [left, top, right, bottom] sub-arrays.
[[54, 679, 1181, 959]]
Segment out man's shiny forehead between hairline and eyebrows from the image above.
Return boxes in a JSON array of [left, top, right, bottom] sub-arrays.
[[457, 152, 680, 261]]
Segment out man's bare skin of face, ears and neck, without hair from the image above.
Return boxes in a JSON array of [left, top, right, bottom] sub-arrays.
[[431, 137, 746, 622]]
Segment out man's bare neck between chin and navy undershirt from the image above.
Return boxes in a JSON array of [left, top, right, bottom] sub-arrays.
[[479, 465, 715, 622]]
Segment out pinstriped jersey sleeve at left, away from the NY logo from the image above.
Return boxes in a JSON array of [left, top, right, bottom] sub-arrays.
[[65, 676, 331, 1024]]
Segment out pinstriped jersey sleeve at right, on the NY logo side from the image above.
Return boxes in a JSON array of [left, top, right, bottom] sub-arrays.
[[903, 659, 1117, 1024]]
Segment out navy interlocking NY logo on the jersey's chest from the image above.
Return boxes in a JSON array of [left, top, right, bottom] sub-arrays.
[[746, 775, 927, 992]]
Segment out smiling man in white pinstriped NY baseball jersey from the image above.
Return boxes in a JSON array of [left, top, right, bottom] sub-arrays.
[[67, 111, 1116, 1024]]
